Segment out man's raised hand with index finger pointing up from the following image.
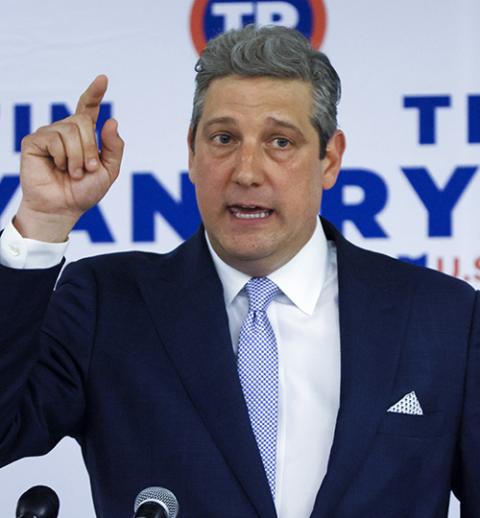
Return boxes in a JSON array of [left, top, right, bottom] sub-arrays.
[[14, 75, 124, 242]]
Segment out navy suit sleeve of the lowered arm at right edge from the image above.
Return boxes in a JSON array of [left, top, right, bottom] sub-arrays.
[[453, 292, 480, 518]]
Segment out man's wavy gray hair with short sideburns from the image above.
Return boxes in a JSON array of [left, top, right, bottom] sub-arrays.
[[191, 25, 341, 158]]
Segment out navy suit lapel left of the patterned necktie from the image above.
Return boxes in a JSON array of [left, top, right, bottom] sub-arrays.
[[139, 232, 276, 518]]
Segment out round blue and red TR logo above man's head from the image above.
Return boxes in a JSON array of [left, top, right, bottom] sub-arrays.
[[190, 0, 327, 54]]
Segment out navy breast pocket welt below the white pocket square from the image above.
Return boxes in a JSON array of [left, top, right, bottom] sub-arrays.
[[378, 412, 444, 439]]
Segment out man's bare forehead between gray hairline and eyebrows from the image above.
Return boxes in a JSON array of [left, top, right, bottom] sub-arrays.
[[201, 75, 312, 128]]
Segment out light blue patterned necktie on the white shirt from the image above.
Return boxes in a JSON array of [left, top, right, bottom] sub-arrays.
[[237, 277, 280, 497]]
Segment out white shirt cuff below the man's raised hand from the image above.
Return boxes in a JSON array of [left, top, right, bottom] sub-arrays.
[[0, 221, 69, 270]]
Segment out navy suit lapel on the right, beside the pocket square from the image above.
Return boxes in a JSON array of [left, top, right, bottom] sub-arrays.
[[311, 222, 411, 518]]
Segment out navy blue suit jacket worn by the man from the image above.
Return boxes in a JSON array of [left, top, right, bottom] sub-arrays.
[[0, 222, 480, 518]]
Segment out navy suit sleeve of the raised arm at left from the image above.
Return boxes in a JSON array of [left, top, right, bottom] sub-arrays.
[[0, 262, 96, 465]]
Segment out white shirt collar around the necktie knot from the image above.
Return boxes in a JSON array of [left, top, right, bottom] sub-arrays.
[[205, 220, 328, 315]]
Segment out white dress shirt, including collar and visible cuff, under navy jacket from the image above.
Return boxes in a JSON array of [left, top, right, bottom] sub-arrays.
[[0, 223, 340, 518]]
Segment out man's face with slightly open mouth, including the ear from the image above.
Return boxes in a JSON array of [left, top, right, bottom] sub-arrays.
[[189, 76, 345, 276]]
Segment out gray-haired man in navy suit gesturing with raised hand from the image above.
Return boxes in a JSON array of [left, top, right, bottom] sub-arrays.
[[0, 27, 480, 518]]
